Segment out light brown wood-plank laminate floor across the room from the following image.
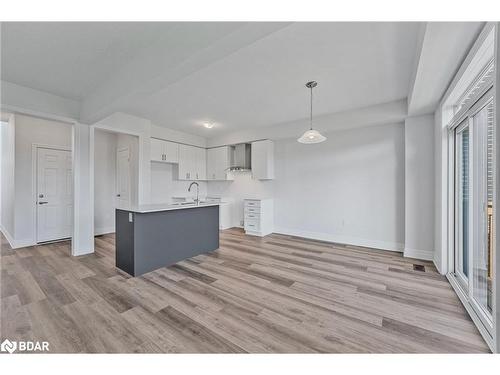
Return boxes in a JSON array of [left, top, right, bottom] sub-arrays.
[[0, 229, 489, 353]]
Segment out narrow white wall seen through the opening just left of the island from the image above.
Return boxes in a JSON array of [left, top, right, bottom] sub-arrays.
[[94, 130, 117, 235]]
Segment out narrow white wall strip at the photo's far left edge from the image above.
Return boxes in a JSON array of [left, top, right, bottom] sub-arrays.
[[0, 116, 15, 241]]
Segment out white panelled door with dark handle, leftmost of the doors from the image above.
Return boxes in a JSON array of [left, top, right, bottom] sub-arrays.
[[36, 147, 73, 242]]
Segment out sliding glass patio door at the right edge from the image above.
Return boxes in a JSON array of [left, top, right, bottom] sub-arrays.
[[454, 89, 495, 332]]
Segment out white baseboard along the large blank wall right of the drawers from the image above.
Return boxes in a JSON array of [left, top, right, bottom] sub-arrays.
[[274, 228, 404, 253]]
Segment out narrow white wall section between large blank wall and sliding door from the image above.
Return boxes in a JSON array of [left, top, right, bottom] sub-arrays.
[[404, 115, 434, 260]]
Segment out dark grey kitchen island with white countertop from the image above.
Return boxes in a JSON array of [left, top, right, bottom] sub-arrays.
[[116, 203, 219, 276]]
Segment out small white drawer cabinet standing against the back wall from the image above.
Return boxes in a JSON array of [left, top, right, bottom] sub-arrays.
[[243, 199, 274, 237]]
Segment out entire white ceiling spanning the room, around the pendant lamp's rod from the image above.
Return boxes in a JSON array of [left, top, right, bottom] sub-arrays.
[[1, 22, 420, 137]]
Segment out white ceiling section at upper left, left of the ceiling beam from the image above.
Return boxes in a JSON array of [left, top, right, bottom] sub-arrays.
[[1, 22, 242, 100]]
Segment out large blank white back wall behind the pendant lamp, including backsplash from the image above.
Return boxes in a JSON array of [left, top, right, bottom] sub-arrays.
[[208, 123, 405, 251]]
